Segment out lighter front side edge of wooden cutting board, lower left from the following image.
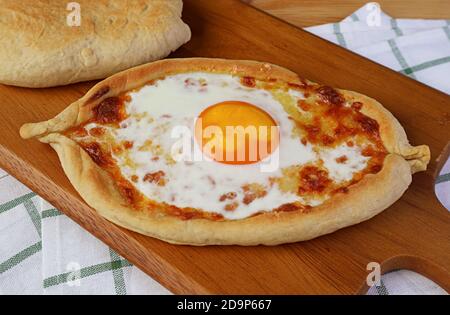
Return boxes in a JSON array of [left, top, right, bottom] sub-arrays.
[[0, 144, 211, 294]]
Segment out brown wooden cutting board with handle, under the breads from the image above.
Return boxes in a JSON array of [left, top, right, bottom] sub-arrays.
[[0, 0, 450, 294]]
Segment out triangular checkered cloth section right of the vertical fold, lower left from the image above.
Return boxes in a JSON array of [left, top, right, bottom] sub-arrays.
[[40, 199, 170, 295]]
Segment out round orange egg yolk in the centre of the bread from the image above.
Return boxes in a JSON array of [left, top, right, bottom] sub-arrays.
[[195, 101, 279, 164]]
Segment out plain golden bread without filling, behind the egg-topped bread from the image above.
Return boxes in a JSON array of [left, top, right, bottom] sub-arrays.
[[0, 0, 191, 87]]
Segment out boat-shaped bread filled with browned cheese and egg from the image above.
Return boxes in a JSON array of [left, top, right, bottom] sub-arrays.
[[20, 58, 430, 245]]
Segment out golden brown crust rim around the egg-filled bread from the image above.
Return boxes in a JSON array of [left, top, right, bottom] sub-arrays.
[[21, 58, 429, 245]]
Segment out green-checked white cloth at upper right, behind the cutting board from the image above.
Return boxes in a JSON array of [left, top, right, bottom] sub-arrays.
[[306, 3, 450, 94]]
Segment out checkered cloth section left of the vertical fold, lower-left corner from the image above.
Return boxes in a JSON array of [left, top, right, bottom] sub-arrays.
[[0, 169, 43, 294]]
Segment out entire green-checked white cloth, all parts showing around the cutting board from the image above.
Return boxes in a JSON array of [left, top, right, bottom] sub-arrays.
[[0, 4, 450, 294]]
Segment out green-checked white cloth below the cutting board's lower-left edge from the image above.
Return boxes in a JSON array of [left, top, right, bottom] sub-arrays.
[[0, 170, 170, 294]]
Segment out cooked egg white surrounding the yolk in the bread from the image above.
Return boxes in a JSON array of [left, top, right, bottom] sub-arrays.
[[82, 72, 367, 219]]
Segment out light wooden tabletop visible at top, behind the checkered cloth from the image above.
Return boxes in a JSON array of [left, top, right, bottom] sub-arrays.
[[245, 0, 450, 27]]
